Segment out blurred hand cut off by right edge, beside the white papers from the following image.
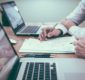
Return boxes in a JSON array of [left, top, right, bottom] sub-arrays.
[[74, 37, 85, 58]]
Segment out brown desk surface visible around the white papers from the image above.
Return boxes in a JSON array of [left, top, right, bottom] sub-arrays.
[[5, 27, 77, 58]]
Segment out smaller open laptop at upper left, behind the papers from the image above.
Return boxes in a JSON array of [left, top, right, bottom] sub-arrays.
[[1, 1, 43, 36]]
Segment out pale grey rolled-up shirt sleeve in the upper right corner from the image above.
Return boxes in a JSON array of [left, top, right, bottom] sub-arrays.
[[67, 0, 85, 25]]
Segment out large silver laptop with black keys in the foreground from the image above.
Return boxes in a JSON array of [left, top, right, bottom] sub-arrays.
[[0, 24, 85, 80]]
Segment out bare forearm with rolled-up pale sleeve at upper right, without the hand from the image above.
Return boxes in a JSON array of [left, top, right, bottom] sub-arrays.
[[61, 0, 85, 29]]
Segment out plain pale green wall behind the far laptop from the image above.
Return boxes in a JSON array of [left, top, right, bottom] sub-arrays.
[[0, 0, 84, 26]]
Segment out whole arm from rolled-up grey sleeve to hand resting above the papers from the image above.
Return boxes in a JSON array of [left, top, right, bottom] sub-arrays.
[[39, 0, 85, 40]]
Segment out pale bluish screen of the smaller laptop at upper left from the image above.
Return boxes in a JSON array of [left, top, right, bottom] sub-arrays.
[[2, 2, 23, 29]]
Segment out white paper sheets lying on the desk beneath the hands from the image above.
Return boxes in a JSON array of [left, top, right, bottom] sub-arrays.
[[19, 37, 75, 54]]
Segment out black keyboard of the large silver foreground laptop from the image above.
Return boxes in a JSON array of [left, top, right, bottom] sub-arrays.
[[22, 63, 57, 80]]
